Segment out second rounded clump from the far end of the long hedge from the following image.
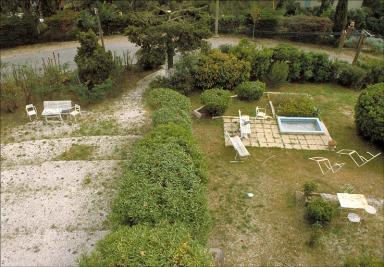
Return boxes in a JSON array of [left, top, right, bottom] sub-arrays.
[[152, 107, 192, 129]]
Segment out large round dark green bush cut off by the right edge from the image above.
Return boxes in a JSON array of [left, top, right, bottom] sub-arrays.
[[355, 83, 384, 144]]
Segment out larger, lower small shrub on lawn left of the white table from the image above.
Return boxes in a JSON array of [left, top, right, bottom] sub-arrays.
[[306, 198, 335, 225]]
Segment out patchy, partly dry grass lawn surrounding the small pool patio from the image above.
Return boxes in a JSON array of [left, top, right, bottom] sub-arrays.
[[191, 84, 384, 266]]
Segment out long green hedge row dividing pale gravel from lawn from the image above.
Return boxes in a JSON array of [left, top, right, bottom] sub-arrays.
[[80, 88, 212, 267]]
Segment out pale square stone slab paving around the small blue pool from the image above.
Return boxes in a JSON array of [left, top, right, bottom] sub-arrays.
[[223, 116, 332, 150]]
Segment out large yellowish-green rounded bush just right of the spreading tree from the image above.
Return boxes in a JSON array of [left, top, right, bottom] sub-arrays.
[[194, 50, 251, 90]]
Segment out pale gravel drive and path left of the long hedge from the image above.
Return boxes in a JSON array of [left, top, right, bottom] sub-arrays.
[[1, 70, 164, 266]]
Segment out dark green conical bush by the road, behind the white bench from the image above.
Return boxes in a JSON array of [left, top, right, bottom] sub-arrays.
[[75, 30, 113, 88]]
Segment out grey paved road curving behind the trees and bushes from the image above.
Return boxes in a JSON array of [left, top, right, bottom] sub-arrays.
[[1, 36, 353, 73]]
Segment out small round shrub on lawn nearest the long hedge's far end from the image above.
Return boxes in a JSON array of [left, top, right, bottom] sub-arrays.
[[200, 88, 231, 116]]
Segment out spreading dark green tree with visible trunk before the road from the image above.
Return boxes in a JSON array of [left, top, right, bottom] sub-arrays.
[[127, 2, 211, 68]]
